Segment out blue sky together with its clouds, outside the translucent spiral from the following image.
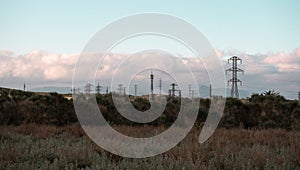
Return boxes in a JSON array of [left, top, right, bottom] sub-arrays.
[[0, 0, 300, 98]]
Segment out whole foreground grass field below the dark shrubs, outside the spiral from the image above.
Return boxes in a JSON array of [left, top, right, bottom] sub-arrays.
[[0, 124, 300, 169]]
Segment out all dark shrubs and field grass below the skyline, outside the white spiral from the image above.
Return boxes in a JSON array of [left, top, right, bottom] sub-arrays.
[[0, 89, 300, 169]]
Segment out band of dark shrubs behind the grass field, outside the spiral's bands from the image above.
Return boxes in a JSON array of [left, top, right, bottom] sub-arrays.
[[0, 89, 300, 130]]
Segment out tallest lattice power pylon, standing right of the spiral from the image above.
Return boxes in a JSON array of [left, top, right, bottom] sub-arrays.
[[226, 56, 244, 98]]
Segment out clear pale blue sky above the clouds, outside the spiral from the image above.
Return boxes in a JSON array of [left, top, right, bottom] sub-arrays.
[[0, 0, 300, 54]]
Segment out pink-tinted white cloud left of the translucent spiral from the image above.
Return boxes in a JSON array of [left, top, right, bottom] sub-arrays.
[[0, 50, 78, 81]]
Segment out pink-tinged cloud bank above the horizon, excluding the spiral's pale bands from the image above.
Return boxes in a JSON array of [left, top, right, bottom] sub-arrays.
[[0, 48, 300, 98]]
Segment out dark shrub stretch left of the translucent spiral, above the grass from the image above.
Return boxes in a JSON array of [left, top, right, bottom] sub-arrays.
[[0, 89, 77, 125]]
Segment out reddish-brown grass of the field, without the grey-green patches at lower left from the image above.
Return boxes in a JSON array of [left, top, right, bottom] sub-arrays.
[[0, 124, 300, 169]]
